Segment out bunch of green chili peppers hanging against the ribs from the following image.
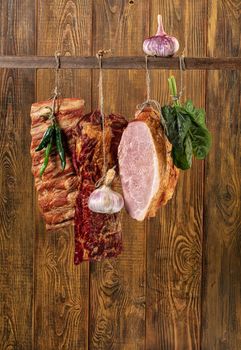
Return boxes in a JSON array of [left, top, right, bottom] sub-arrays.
[[35, 109, 66, 177]]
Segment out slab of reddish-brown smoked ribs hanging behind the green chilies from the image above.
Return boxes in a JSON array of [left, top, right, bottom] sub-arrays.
[[30, 98, 84, 230]]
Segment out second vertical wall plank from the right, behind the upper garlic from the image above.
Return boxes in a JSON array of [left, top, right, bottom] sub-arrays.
[[146, 0, 207, 350]]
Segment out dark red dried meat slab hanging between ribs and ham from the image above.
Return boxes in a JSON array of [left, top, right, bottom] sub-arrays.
[[73, 111, 127, 264]]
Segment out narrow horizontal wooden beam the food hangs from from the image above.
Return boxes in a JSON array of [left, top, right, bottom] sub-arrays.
[[0, 56, 241, 70]]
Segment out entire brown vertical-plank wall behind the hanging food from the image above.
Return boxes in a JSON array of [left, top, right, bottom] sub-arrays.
[[0, 0, 241, 350]]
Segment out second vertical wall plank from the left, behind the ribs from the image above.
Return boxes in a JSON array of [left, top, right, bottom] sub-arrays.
[[35, 0, 92, 350]]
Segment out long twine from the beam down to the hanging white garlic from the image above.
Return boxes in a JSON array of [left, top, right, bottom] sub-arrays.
[[95, 50, 111, 187]]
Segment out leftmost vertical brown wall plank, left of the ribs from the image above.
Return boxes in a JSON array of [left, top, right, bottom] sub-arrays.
[[0, 0, 35, 350]]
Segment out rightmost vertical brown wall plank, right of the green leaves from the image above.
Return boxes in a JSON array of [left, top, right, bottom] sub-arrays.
[[202, 0, 241, 350]]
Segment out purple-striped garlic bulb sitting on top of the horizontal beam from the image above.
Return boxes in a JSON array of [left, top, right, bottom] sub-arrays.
[[143, 15, 179, 57]]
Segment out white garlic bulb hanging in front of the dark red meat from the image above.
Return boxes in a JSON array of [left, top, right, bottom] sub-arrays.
[[88, 169, 124, 214]]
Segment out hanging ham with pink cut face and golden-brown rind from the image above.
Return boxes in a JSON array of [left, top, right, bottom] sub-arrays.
[[118, 107, 179, 221]]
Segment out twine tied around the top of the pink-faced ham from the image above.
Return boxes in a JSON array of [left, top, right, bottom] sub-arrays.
[[137, 55, 167, 134]]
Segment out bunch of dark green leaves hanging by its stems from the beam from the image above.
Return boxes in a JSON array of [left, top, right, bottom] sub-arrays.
[[162, 76, 211, 170]]
